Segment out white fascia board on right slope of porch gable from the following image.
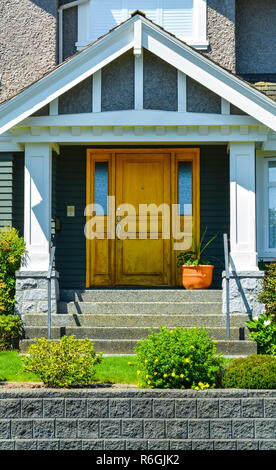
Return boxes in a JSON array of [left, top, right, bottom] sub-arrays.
[[142, 18, 276, 130]]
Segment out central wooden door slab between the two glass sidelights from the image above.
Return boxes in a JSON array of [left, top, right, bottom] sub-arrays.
[[116, 153, 170, 285]]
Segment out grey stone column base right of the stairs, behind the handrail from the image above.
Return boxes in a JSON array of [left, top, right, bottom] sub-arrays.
[[222, 270, 265, 318]]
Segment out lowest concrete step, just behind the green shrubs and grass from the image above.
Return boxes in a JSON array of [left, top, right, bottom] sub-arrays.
[[20, 338, 257, 357]]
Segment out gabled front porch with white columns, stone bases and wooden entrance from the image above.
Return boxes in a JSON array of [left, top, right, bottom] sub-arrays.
[[0, 12, 276, 352]]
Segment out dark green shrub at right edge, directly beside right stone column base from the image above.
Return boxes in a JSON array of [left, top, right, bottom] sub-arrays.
[[258, 263, 276, 323]]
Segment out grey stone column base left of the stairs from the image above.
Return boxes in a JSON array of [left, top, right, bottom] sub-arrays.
[[14, 271, 59, 316]]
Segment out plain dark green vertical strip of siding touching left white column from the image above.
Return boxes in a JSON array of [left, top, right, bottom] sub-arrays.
[[12, 153, 24, 236]]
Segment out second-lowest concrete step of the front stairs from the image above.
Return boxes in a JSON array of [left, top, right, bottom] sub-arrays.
[[24, 326, 248, 341]]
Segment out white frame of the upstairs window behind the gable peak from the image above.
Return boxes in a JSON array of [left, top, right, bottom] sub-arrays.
[[76, 0, 209, 50]]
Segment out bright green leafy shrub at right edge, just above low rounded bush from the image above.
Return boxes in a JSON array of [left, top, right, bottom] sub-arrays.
[[245, 314, 276, 356]]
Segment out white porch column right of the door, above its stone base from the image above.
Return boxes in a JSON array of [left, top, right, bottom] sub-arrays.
[[230, 143, 258, 272]]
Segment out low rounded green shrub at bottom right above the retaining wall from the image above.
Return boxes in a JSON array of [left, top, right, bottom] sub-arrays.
[[222, 354, 276, 390]]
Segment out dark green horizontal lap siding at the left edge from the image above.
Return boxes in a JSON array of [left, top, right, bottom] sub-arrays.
[[0, 153, 13, 227]]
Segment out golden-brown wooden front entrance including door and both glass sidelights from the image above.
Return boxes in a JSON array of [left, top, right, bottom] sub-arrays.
[[86, 149, 199, 287]]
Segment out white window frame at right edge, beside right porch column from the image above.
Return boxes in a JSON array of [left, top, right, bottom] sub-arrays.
[[256, 152, 276, 261]]
